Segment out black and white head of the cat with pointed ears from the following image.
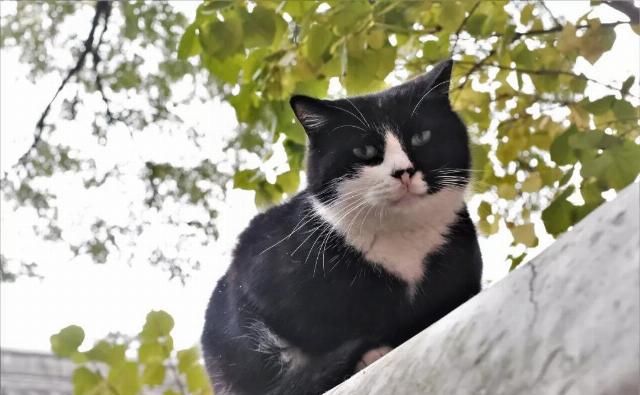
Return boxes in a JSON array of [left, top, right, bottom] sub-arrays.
[[291, 60, 470, 210]]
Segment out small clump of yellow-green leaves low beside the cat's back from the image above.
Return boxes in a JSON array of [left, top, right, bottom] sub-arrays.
[[51, 311, 213, 395]]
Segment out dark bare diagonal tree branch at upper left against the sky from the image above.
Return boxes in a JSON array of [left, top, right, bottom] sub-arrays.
[[12, 0, 111, 167]]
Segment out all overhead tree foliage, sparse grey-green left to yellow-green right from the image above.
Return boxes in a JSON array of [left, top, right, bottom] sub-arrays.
[[2, 0, 640, 277]]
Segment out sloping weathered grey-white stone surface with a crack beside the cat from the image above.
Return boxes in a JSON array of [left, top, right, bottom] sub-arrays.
[[329, 184, 640, 395]]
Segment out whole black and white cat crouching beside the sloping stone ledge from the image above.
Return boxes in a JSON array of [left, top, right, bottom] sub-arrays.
[[202, 61, 482, 395]]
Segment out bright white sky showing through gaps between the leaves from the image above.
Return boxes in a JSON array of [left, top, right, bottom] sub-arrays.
[[0, 1, 640, 351]]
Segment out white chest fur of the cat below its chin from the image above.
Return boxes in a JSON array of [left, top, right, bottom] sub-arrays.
[[313, 189, 464, 289]]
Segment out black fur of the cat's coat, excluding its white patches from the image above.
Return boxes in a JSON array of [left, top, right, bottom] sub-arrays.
[[202, 61, 482, 394]]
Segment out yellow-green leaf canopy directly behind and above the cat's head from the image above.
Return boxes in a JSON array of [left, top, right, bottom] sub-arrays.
[[178, 0, 640, 267]]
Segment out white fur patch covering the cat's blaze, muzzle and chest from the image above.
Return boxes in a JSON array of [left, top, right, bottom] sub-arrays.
[[313, 128, 464, 295]]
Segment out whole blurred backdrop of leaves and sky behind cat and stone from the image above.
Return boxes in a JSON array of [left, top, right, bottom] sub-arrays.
[[0, 0, 640, 394]]
